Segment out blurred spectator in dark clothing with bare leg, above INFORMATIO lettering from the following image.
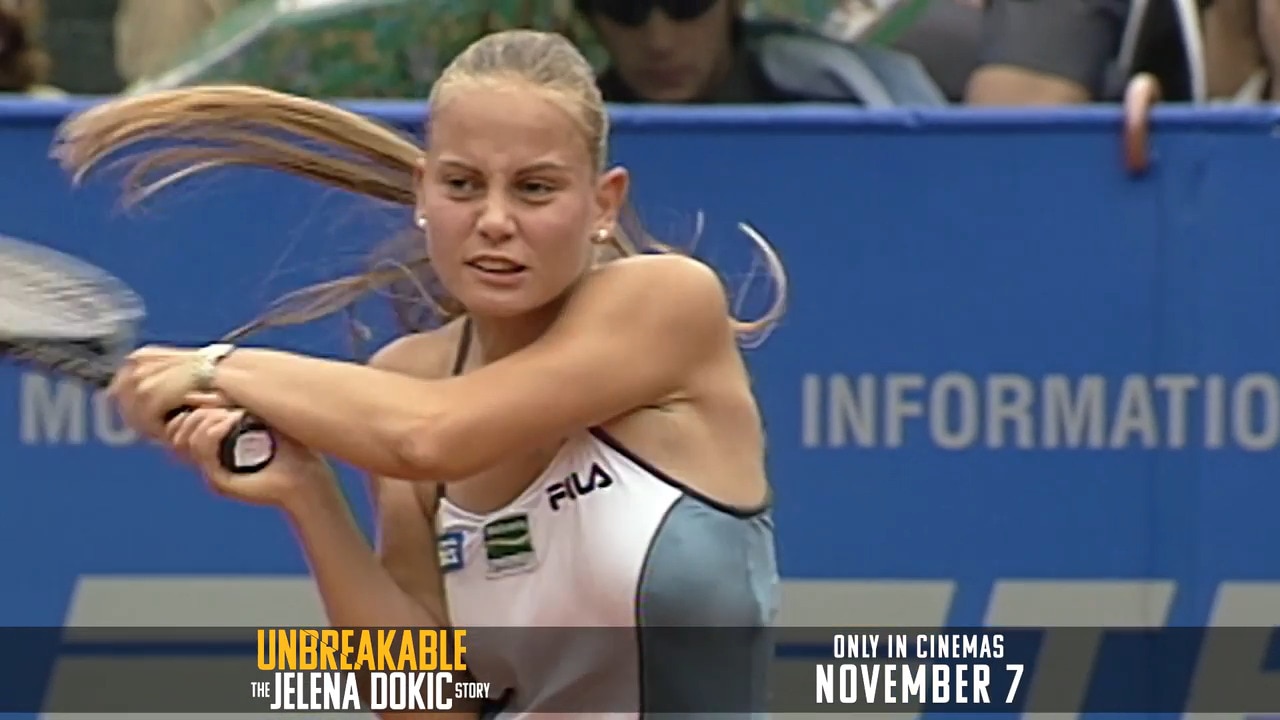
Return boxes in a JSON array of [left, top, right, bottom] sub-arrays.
[[966, 0, 1199, 105]]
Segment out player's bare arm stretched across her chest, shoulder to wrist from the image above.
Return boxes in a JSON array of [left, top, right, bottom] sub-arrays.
[[215, 256, 732, 482]]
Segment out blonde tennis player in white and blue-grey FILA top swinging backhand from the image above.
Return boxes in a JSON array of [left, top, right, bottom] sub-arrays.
[[59, 31, 785, 717]]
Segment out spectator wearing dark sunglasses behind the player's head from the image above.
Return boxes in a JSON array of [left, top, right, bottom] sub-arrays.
[[576, 0, 946, 106]]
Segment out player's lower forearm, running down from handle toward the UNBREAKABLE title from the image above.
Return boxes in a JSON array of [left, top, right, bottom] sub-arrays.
[[285, 480, 447, 628]]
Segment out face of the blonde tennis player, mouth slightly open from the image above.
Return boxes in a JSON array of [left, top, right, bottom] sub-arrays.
[[419, 85, 626, 318]]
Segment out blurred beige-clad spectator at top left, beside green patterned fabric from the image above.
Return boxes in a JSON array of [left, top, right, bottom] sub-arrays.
[[115, 0, 242, 85]]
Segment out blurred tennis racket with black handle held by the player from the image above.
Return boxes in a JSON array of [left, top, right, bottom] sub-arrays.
[[0, 236, 275, 474]]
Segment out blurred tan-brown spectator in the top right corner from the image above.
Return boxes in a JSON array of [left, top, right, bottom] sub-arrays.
[[1204, 0, 1280, 102]]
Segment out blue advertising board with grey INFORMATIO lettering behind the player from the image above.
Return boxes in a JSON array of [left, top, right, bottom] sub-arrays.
[[0, 98, 1280, 712]]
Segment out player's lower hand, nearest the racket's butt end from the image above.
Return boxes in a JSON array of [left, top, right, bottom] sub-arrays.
[[164, 406, 333, 507]]
